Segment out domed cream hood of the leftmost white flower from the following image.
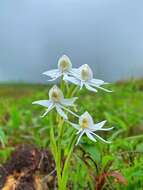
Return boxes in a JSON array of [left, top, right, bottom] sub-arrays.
[[49, 85, 64, 102]]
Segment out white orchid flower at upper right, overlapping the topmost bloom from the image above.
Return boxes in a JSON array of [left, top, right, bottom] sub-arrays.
[[64, 64, 112, 92]]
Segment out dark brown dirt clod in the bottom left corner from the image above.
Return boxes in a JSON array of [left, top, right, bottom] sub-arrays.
[[0, 145, 55, 190]]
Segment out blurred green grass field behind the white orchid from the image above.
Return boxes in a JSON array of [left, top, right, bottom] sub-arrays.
[[0, 80, 143, 190]]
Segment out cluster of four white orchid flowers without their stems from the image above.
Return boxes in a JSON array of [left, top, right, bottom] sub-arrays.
[[33, 55, 113, 145]]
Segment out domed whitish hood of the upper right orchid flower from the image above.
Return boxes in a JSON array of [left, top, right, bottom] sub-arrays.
[[79, 64, 93, 81]]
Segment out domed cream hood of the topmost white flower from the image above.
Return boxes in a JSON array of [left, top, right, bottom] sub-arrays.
[[58, 55, 72, 73]]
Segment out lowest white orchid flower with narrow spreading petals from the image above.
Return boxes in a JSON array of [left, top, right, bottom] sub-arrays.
[[67, 112, 113, 145]]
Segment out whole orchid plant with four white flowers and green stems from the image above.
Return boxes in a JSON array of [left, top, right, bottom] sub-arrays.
[[33, 55, 113, 190]]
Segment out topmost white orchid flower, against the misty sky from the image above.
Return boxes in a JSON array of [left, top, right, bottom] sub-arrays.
[[43, 55, 77, 81]]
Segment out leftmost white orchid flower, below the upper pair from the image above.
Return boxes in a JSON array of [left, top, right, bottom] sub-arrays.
[[32, 85, 79, 120]]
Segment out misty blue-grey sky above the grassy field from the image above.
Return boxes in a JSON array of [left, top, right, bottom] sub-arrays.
[[0, 0, 143, 82]]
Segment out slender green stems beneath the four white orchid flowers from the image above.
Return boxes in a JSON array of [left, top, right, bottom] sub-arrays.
[[50, 81, 78, 190]]
